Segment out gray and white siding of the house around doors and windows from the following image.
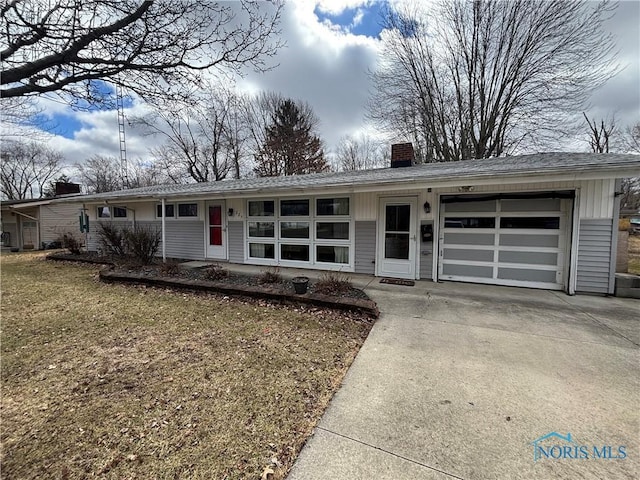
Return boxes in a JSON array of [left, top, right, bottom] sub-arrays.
[[74, 175, 615, 293]]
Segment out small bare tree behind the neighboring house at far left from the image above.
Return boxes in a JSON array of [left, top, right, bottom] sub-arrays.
[[0, 140, 63, 200]]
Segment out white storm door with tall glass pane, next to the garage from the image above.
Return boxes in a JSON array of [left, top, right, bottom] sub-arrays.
[[376, 197, 416, 280]]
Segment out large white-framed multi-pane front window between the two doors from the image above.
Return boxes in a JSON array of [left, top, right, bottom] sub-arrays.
[[246, 197, 354, 269]]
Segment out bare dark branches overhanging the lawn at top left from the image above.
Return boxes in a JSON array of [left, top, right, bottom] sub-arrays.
[[0, 0, 282, 104]]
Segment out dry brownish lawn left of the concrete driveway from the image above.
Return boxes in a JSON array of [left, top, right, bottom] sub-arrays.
[[0, 253, 370, 479]]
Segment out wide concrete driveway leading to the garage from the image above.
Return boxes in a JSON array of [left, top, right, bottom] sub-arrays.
[[288, 280, 640, 480]]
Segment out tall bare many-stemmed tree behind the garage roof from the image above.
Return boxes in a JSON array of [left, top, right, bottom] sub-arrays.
[[370, 0, 613, 161]]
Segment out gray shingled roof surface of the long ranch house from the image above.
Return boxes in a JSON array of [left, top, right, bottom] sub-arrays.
[[67, 153, 640, 201]]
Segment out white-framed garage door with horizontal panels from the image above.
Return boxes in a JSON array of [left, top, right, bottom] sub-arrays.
[[438, 195, 573, 290]]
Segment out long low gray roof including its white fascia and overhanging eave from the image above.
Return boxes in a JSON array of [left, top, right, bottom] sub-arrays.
[[55, 153, 640, 204]]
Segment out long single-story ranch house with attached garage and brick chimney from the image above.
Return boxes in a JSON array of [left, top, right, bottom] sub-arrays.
[[57, 144, 640, 294]]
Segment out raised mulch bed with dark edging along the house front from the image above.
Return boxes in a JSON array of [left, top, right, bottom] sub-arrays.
[[47, 253, 380, 318]]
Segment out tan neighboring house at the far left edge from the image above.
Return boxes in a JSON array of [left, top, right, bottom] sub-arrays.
[[0, 198, 80, 250]]
